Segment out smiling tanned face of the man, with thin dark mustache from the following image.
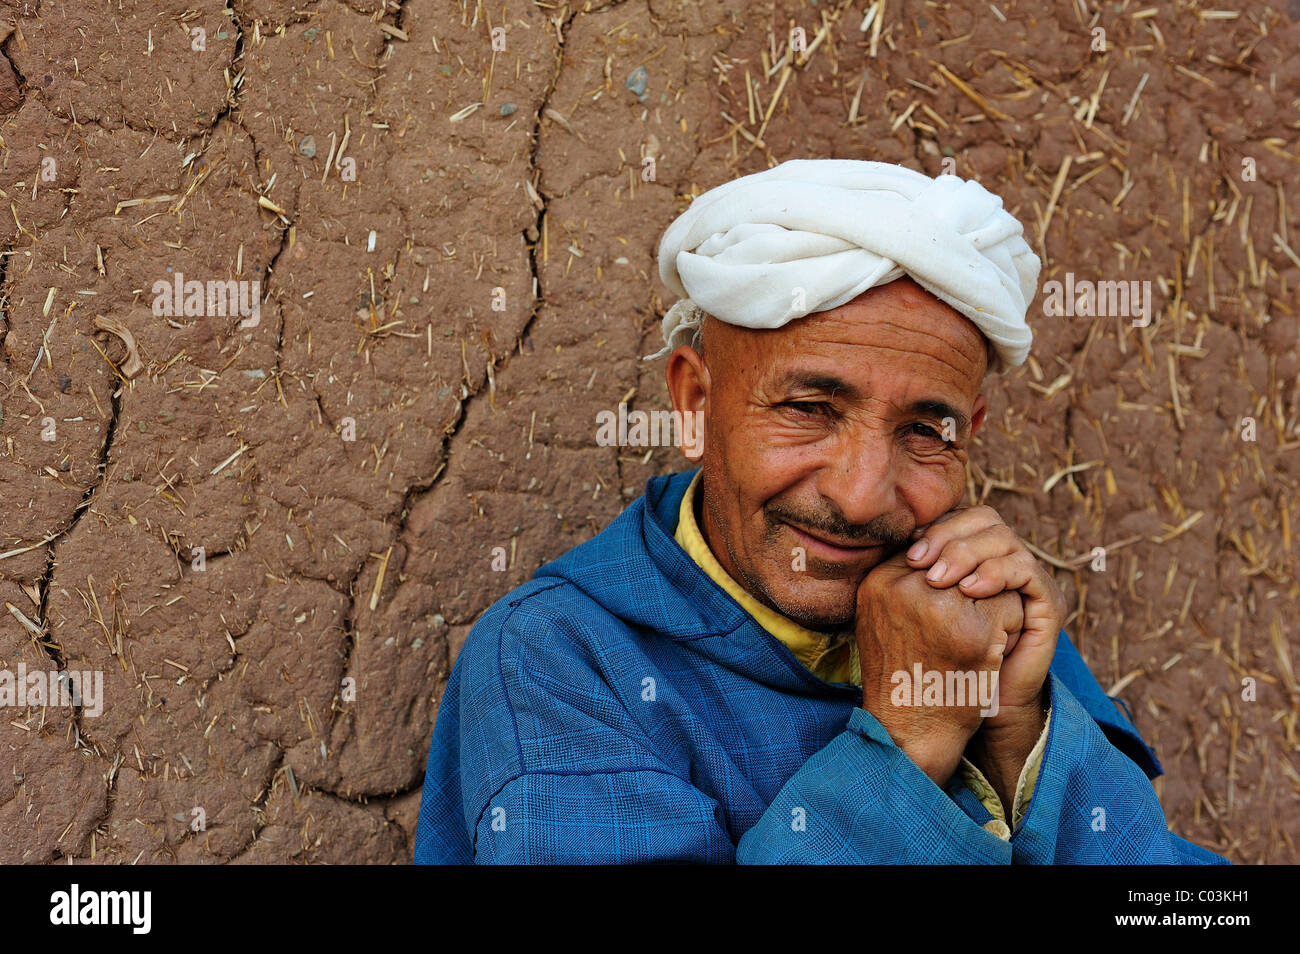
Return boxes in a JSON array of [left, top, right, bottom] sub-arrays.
[[667, 278, 987, 632]]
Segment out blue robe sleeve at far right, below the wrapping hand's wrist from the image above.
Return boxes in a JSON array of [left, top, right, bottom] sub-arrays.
[[1010, 673, 1227, 864]]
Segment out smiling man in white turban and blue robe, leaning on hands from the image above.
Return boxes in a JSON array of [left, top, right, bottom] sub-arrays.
[[416, 160, 1222, 864]]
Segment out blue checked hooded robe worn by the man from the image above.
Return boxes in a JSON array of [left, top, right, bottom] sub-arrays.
[[415, 472, 1225, 864]]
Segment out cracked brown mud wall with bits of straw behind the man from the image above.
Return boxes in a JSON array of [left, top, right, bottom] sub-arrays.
[[0, 0, 1300, 863]]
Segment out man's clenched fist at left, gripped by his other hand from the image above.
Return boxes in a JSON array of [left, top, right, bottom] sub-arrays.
[[855, 554, 1024, 786]]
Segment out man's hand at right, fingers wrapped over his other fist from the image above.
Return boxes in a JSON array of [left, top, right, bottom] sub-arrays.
[[907, 507, 1066, 727]]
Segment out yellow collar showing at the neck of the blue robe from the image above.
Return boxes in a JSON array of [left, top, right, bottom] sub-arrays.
[[673, 471, 862, 685]]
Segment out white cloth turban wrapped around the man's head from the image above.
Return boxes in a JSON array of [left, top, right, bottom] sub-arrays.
[[647, 159, 1041, 370]]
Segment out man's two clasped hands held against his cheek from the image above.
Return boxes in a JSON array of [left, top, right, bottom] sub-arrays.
[[855, 507, 1066, 818]]
